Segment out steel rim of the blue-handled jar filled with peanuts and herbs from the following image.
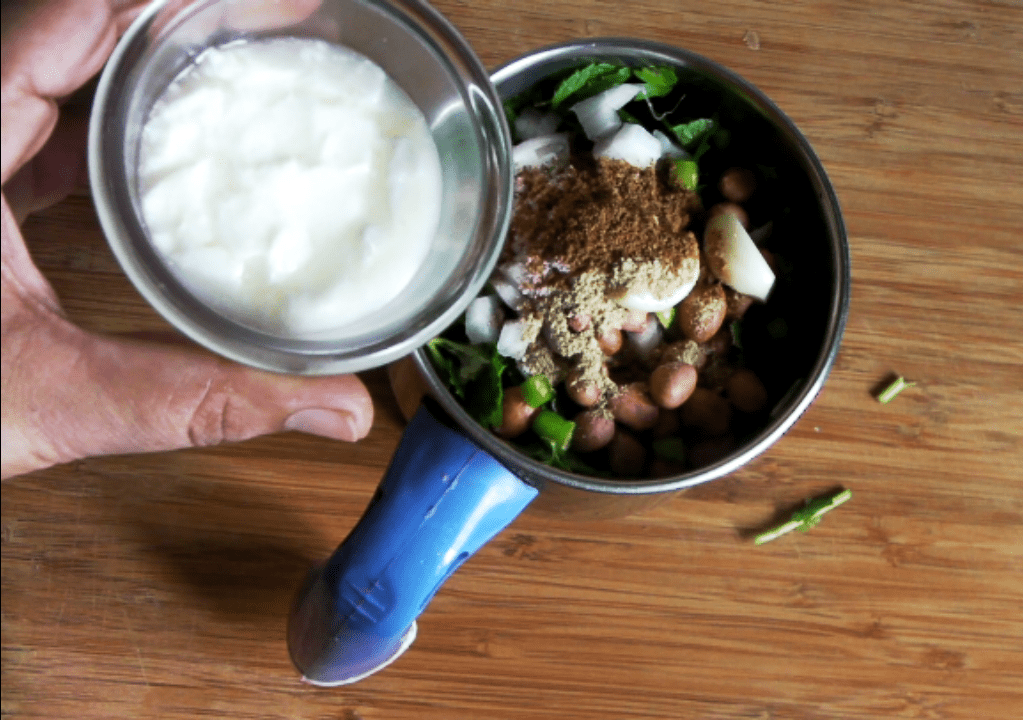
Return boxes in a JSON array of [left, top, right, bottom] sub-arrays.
[[412, 37, 852, 495]]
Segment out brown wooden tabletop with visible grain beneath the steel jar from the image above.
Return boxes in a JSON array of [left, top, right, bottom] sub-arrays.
[[2, 0, 1023, 720]]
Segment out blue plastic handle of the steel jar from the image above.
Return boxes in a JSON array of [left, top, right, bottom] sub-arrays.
[[287, 404, 537, 685]]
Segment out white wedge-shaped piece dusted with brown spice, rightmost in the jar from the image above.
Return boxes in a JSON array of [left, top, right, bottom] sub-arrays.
[[704, 213, 774, 302]]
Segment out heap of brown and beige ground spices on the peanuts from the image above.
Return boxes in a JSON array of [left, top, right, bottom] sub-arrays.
[[502, 155, 700, 407]]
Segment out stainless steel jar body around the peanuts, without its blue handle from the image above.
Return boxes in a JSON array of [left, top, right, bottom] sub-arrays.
[[414, 38, 850, 515]]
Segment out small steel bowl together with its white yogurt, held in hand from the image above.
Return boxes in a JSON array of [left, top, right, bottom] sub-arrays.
[[89, 0, 512, 374]]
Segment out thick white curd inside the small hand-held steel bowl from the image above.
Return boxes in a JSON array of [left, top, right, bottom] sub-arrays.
[[139, 39, 442, 338]]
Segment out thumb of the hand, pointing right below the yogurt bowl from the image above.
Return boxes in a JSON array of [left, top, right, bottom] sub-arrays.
[[3, 313, 373, 478]]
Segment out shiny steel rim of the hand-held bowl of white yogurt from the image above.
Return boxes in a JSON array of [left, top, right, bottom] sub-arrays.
[[87, 0, 514, 375]]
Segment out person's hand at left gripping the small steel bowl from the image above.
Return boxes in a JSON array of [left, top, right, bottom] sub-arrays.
[[0, 0, 373, 479]]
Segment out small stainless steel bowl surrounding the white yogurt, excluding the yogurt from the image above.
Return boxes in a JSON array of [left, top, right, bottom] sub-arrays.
[[89, 0, 512, 374]]
